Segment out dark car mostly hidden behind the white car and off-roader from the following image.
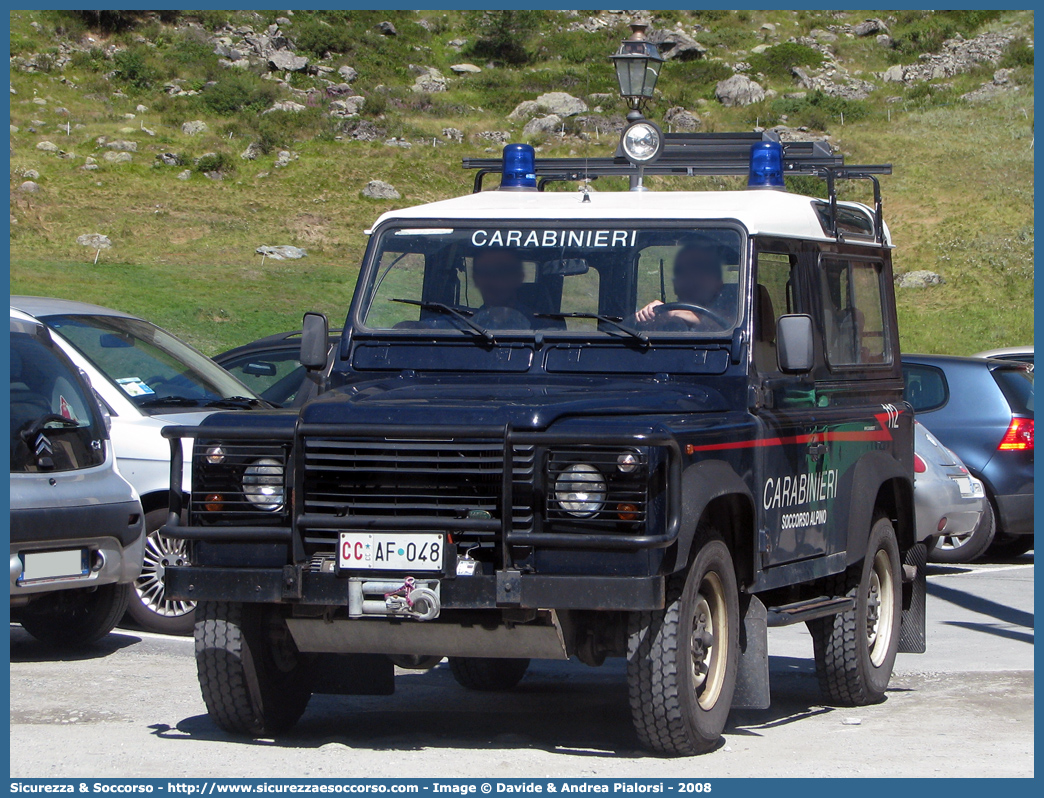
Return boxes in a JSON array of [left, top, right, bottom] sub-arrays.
[[214, 330, 339, 407]]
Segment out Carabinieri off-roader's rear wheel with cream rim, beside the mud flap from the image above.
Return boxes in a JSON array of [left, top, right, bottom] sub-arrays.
[[808, 518, 902, 706]]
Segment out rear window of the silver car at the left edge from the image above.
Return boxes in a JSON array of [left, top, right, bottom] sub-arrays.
[[10, 332, 104, 471]]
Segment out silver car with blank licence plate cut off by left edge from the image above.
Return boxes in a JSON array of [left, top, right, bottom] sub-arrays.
[[9, 308, 145, 646]]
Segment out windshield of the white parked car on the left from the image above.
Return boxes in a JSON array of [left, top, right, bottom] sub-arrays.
[[45, 315, 256, 413]]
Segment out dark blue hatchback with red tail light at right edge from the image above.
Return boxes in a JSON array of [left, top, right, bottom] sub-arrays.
[[903, 355, 1034, 556]]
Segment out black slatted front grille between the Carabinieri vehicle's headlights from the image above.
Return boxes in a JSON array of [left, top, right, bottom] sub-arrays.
[[302, 438, 535, 545]]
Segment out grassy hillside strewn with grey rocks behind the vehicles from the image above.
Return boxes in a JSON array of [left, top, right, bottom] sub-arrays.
[[10, 10, 1034, 354]]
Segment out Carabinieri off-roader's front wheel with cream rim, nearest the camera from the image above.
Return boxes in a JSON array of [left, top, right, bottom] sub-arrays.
[[627, 529, 739, 755]]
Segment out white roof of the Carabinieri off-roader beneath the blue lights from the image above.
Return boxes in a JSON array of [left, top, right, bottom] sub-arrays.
[[366, 190, 892, 247]]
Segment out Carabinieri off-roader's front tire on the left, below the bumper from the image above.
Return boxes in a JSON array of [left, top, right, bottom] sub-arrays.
[[195, 602, 312, 737]]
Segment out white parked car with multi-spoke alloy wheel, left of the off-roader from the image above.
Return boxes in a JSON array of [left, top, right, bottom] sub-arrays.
[[10, 297, 269, 634]]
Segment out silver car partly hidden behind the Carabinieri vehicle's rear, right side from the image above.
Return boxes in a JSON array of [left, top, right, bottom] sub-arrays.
[[914, 422, 994, 563]]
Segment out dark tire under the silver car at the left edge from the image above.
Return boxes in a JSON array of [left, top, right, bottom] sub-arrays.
[[21, 584, 131, 649]]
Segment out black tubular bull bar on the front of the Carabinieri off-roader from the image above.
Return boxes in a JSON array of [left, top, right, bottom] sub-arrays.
[[161, 421, 682, 563]]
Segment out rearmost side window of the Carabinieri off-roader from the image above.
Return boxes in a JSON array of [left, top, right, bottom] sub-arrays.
[[821, 260, 892, 367]]
